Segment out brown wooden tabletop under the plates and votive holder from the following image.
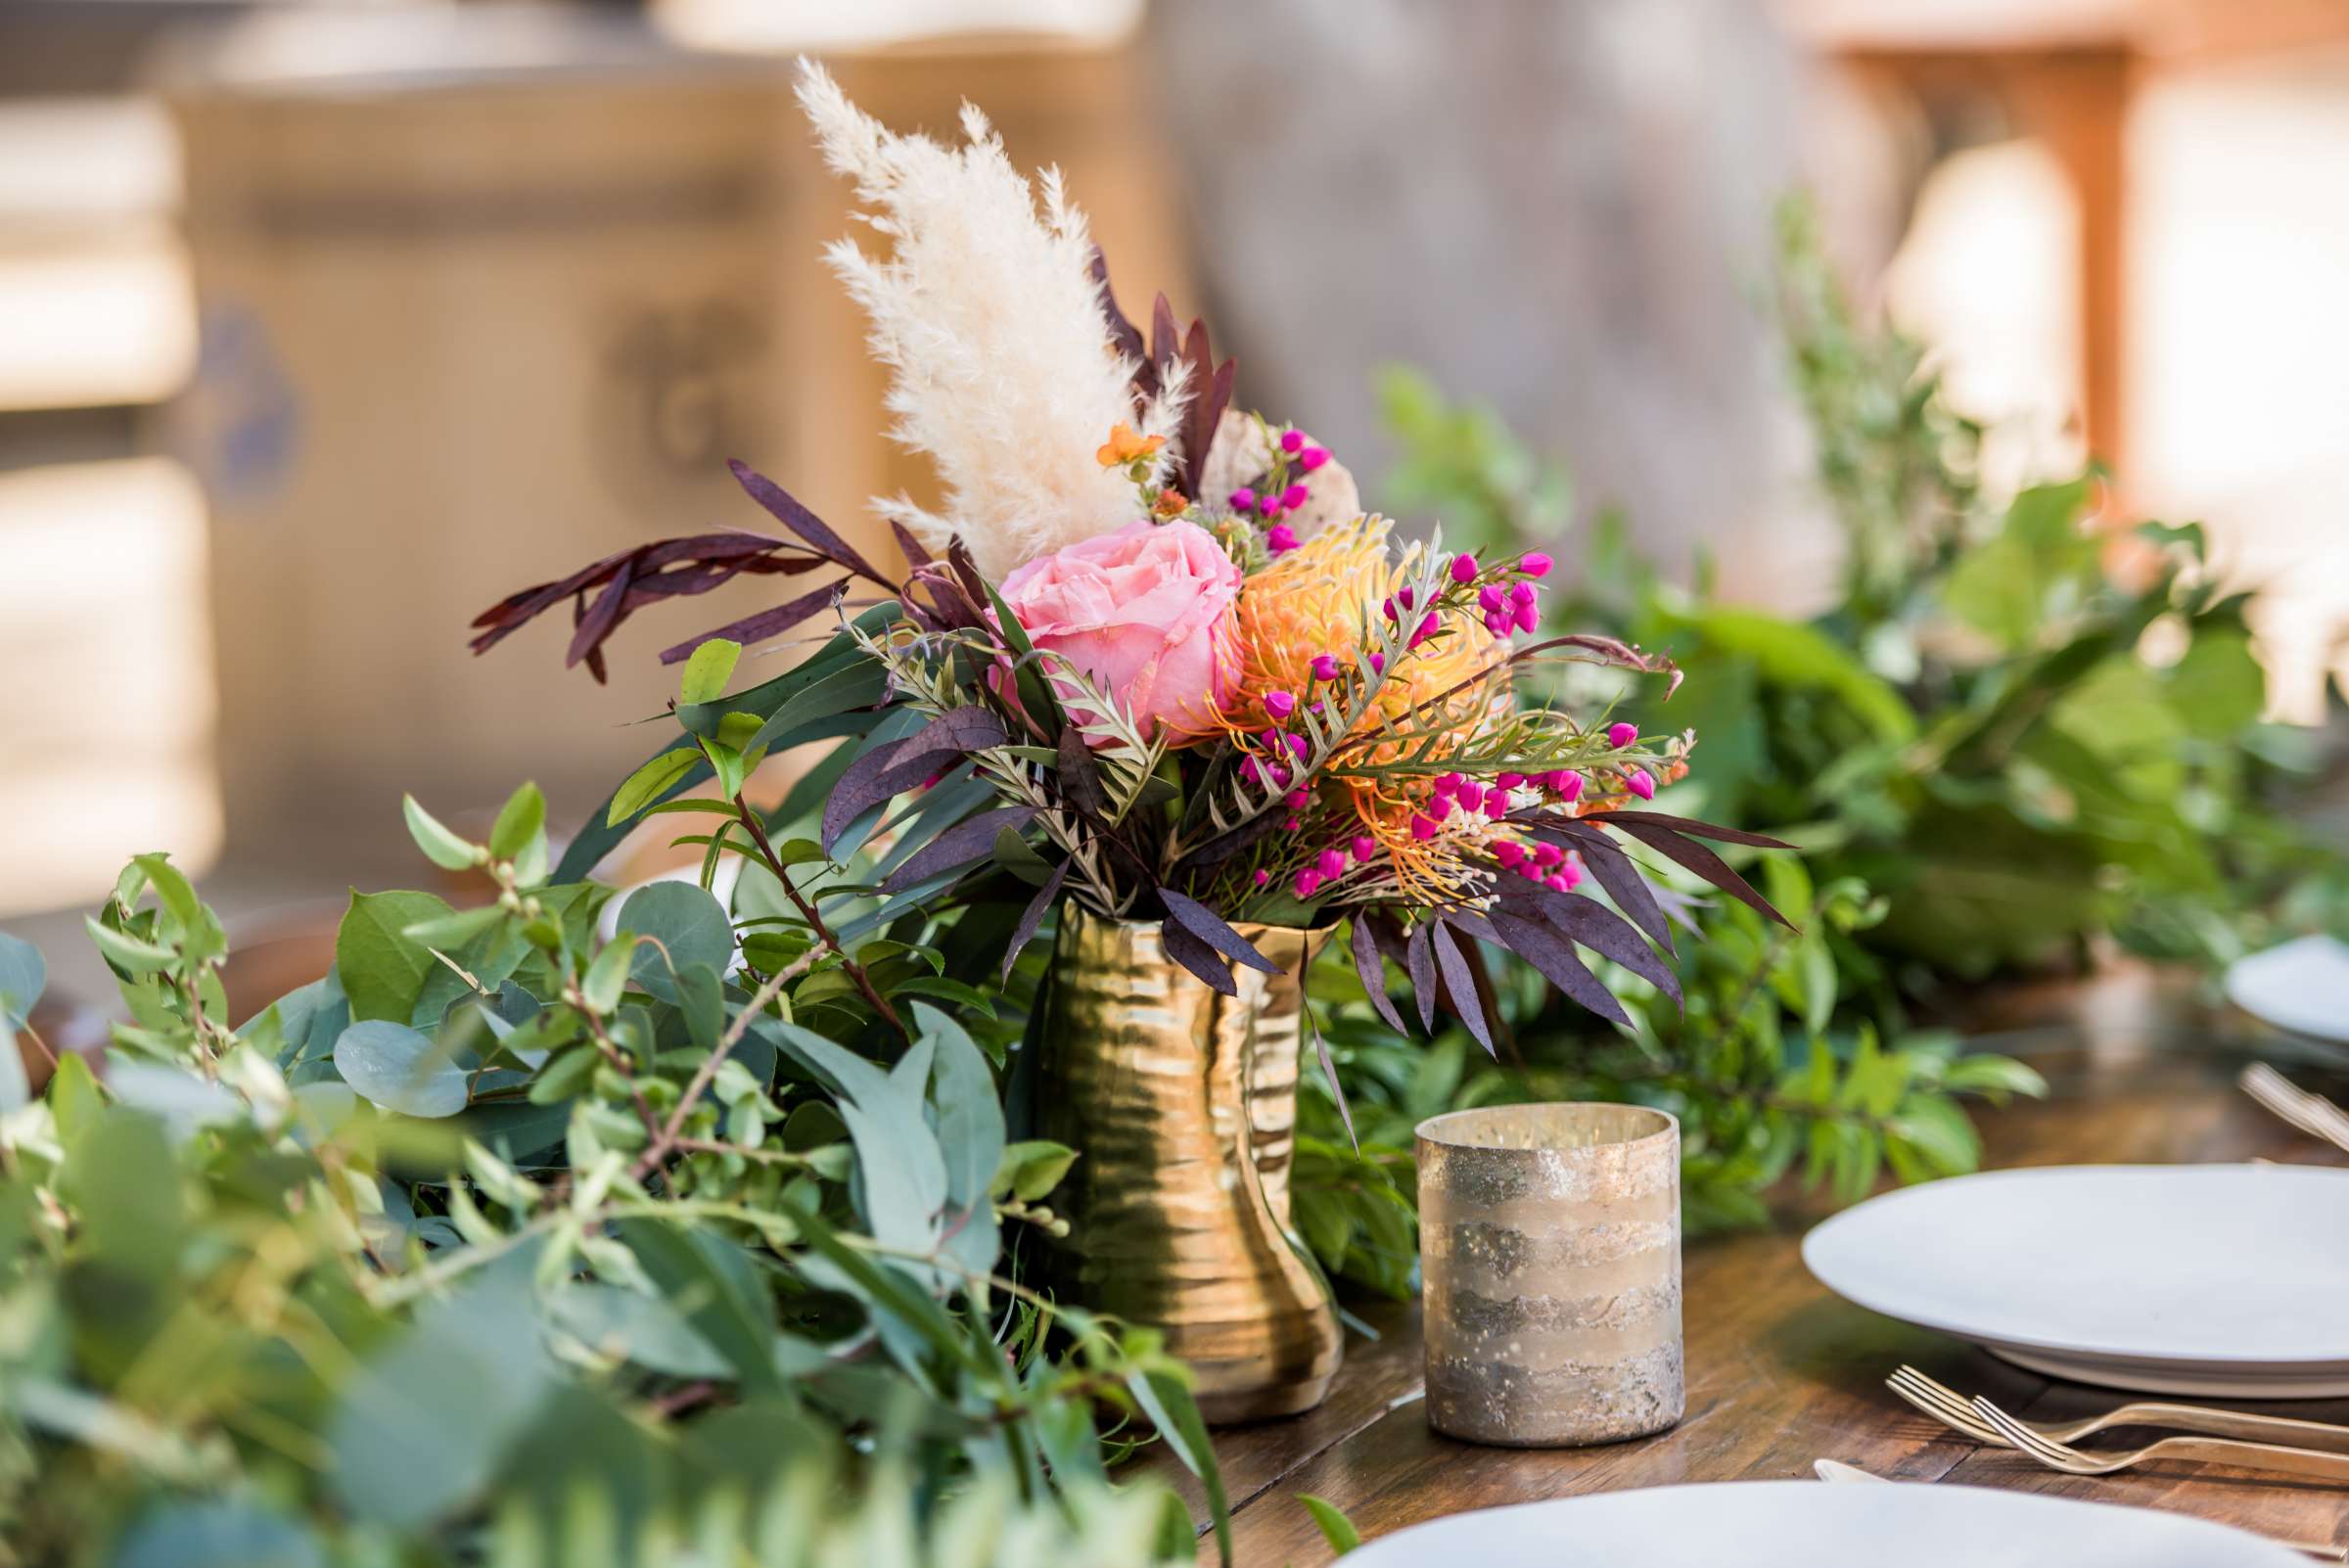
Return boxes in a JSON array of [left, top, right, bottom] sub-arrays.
[[1126, 971, 2349, 1568]]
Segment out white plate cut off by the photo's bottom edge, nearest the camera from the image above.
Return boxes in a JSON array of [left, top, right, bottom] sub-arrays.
[[1346, 1481, 2307, 1568]]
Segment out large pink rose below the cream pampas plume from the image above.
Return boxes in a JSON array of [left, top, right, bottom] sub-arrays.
[[1003, 519, 1240, 739]]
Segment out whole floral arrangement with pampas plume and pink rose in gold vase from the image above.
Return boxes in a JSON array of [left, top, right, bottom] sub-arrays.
[[475, 69, 1775, 1418]]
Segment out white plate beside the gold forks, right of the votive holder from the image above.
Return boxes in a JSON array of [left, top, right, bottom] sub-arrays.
[[1802, 1165, 2349, 1399]]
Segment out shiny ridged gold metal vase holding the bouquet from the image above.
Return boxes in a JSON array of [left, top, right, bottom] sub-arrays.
[[1036, 903, 1344, 1422]]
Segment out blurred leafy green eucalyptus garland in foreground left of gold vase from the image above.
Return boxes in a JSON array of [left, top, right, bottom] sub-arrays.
[[0, 803, 1221, 1568]]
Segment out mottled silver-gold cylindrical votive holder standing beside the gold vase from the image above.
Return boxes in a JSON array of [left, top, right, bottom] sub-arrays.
[[1419, 1106, 1686, 1449]]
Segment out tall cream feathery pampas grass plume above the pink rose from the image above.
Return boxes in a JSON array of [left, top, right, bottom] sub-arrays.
[[799, 59, 1184, 579]]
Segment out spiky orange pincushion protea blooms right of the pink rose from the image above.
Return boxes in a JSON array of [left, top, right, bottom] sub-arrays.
[[1223, 517, 1510, 899]]
